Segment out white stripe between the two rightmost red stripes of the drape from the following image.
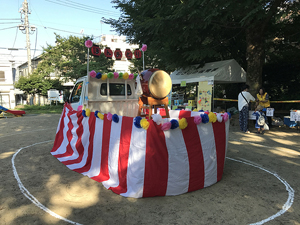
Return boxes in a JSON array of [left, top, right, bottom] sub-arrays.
[[197, 123, 218, 187]]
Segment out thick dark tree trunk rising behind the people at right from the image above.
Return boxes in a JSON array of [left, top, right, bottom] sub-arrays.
[[246, 28, 265, 96]]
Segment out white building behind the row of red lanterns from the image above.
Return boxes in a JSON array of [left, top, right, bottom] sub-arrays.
[[100, 34, 139, 73]]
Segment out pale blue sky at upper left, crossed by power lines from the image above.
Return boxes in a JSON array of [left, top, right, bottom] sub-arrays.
[[0, 0, 120, 63]]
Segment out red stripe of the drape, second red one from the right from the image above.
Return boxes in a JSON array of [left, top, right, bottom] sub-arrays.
[[182, 117, 205, 192]]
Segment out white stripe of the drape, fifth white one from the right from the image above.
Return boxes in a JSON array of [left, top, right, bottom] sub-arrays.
[[82, 118, 104, 177]]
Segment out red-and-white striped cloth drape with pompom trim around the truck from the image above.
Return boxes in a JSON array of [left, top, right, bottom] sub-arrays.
[[51, 103, 230, 198]]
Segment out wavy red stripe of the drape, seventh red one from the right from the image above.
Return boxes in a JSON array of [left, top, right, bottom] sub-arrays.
[[62, 111, 84, 165]]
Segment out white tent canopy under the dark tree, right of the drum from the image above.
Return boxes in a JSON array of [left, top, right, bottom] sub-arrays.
[[170, 59, 246, 84]]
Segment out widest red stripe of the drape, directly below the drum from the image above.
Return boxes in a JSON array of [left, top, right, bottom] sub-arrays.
[[143, 120, 169, 197]]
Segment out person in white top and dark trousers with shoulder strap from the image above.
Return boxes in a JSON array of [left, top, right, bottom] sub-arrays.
[[238, 84, 255, 133]]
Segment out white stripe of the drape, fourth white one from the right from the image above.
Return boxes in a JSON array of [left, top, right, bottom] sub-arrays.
[[102, 116, 122, 189]]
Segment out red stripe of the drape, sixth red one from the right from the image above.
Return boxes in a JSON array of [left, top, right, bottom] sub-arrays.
[[73, 113, 96, 173]]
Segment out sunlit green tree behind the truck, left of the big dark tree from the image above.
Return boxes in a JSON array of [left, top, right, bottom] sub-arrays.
[[42, 34, 114, 80]]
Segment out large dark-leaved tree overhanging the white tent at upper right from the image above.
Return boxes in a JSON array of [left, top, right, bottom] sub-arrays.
[[105, 0, 299, 92]]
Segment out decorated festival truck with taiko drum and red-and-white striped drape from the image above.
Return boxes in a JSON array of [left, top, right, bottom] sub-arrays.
[[51, 39, 230, 198]]
